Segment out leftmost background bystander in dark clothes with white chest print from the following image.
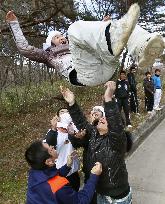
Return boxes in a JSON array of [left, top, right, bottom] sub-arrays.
[[115, 70, 132, 127]]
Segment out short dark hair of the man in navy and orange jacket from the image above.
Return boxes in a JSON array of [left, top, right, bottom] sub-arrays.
[[25, 140, 50, 170]]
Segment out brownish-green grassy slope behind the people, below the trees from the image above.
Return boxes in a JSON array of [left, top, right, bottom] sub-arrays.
[[0, 74, 165, 204]]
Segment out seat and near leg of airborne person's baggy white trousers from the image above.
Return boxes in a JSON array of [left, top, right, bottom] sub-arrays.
[[68, 21, 117, 86]]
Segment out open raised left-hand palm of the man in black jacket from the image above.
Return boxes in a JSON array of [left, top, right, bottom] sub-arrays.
[[60, 86, 75, 106]]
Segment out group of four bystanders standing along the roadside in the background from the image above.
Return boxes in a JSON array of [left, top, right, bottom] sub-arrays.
[[115, 65, 162, 128]]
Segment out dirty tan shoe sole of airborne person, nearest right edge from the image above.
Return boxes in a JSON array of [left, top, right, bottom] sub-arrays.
[[138, 35, 164, 68]]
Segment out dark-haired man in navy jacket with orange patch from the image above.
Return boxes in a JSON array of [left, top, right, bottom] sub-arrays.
[[25, 136, 102, 204]]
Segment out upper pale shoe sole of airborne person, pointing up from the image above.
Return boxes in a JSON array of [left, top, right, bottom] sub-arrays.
[[113, 3, 140, 56]]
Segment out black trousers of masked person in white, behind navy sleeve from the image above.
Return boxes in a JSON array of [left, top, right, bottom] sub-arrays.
[[67, 171, 80, 192]]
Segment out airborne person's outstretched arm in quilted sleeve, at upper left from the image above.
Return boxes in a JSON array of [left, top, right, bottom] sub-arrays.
[[6, 11, 49, 63]]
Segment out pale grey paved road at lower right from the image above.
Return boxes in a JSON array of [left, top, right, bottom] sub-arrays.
[[126, 119, 165, 204]]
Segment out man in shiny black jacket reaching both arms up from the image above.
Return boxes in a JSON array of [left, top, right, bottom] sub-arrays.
[[61, 81, 132, 204]]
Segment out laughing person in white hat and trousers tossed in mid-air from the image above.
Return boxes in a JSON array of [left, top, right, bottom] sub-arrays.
[[6, 4, 164, 86]]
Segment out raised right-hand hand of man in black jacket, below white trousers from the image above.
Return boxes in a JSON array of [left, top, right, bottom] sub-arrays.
[[104, 81, 116, 102]]
